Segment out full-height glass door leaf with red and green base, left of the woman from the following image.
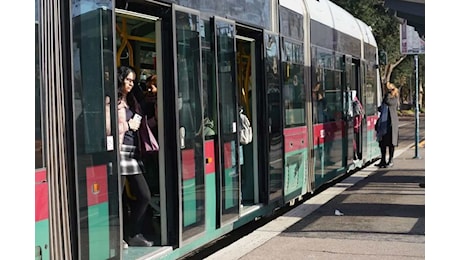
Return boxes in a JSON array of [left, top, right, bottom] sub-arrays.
[[69, 6, 121, 259]]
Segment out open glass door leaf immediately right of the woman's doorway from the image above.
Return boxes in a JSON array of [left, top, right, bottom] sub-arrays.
[[173, 5, 208, 246]]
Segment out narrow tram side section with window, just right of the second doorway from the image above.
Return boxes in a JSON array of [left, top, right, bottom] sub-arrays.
[[279, 8, 310, 200]]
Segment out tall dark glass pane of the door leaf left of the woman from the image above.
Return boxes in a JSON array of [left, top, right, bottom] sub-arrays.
[[73, 9, 114, 154]]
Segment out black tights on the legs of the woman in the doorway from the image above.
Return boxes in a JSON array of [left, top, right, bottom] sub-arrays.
[[121, 174, 152, 237]]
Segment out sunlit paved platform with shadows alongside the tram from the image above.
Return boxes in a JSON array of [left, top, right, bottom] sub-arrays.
[[206, 142, 425, 260]]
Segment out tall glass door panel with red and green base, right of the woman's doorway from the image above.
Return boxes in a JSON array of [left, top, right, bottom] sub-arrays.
[[175, 11, 205, 240]]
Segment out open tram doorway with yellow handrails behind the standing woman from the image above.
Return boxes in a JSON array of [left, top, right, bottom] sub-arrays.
[[115, 9, 166, 245]]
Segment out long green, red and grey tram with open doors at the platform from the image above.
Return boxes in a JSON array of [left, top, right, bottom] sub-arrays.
[[35, 0, 381, 259]]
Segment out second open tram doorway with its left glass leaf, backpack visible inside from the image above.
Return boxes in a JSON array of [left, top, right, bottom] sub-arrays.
[[205, 17, 262, 226]]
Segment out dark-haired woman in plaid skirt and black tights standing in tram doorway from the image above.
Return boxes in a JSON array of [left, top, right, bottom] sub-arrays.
[[118, 66, 153, 248]]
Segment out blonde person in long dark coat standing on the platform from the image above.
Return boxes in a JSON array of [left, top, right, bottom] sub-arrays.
[[376, 82, 399, 168]]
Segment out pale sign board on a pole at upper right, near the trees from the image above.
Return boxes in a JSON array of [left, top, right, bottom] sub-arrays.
[[399, 21, 425, 54]]
